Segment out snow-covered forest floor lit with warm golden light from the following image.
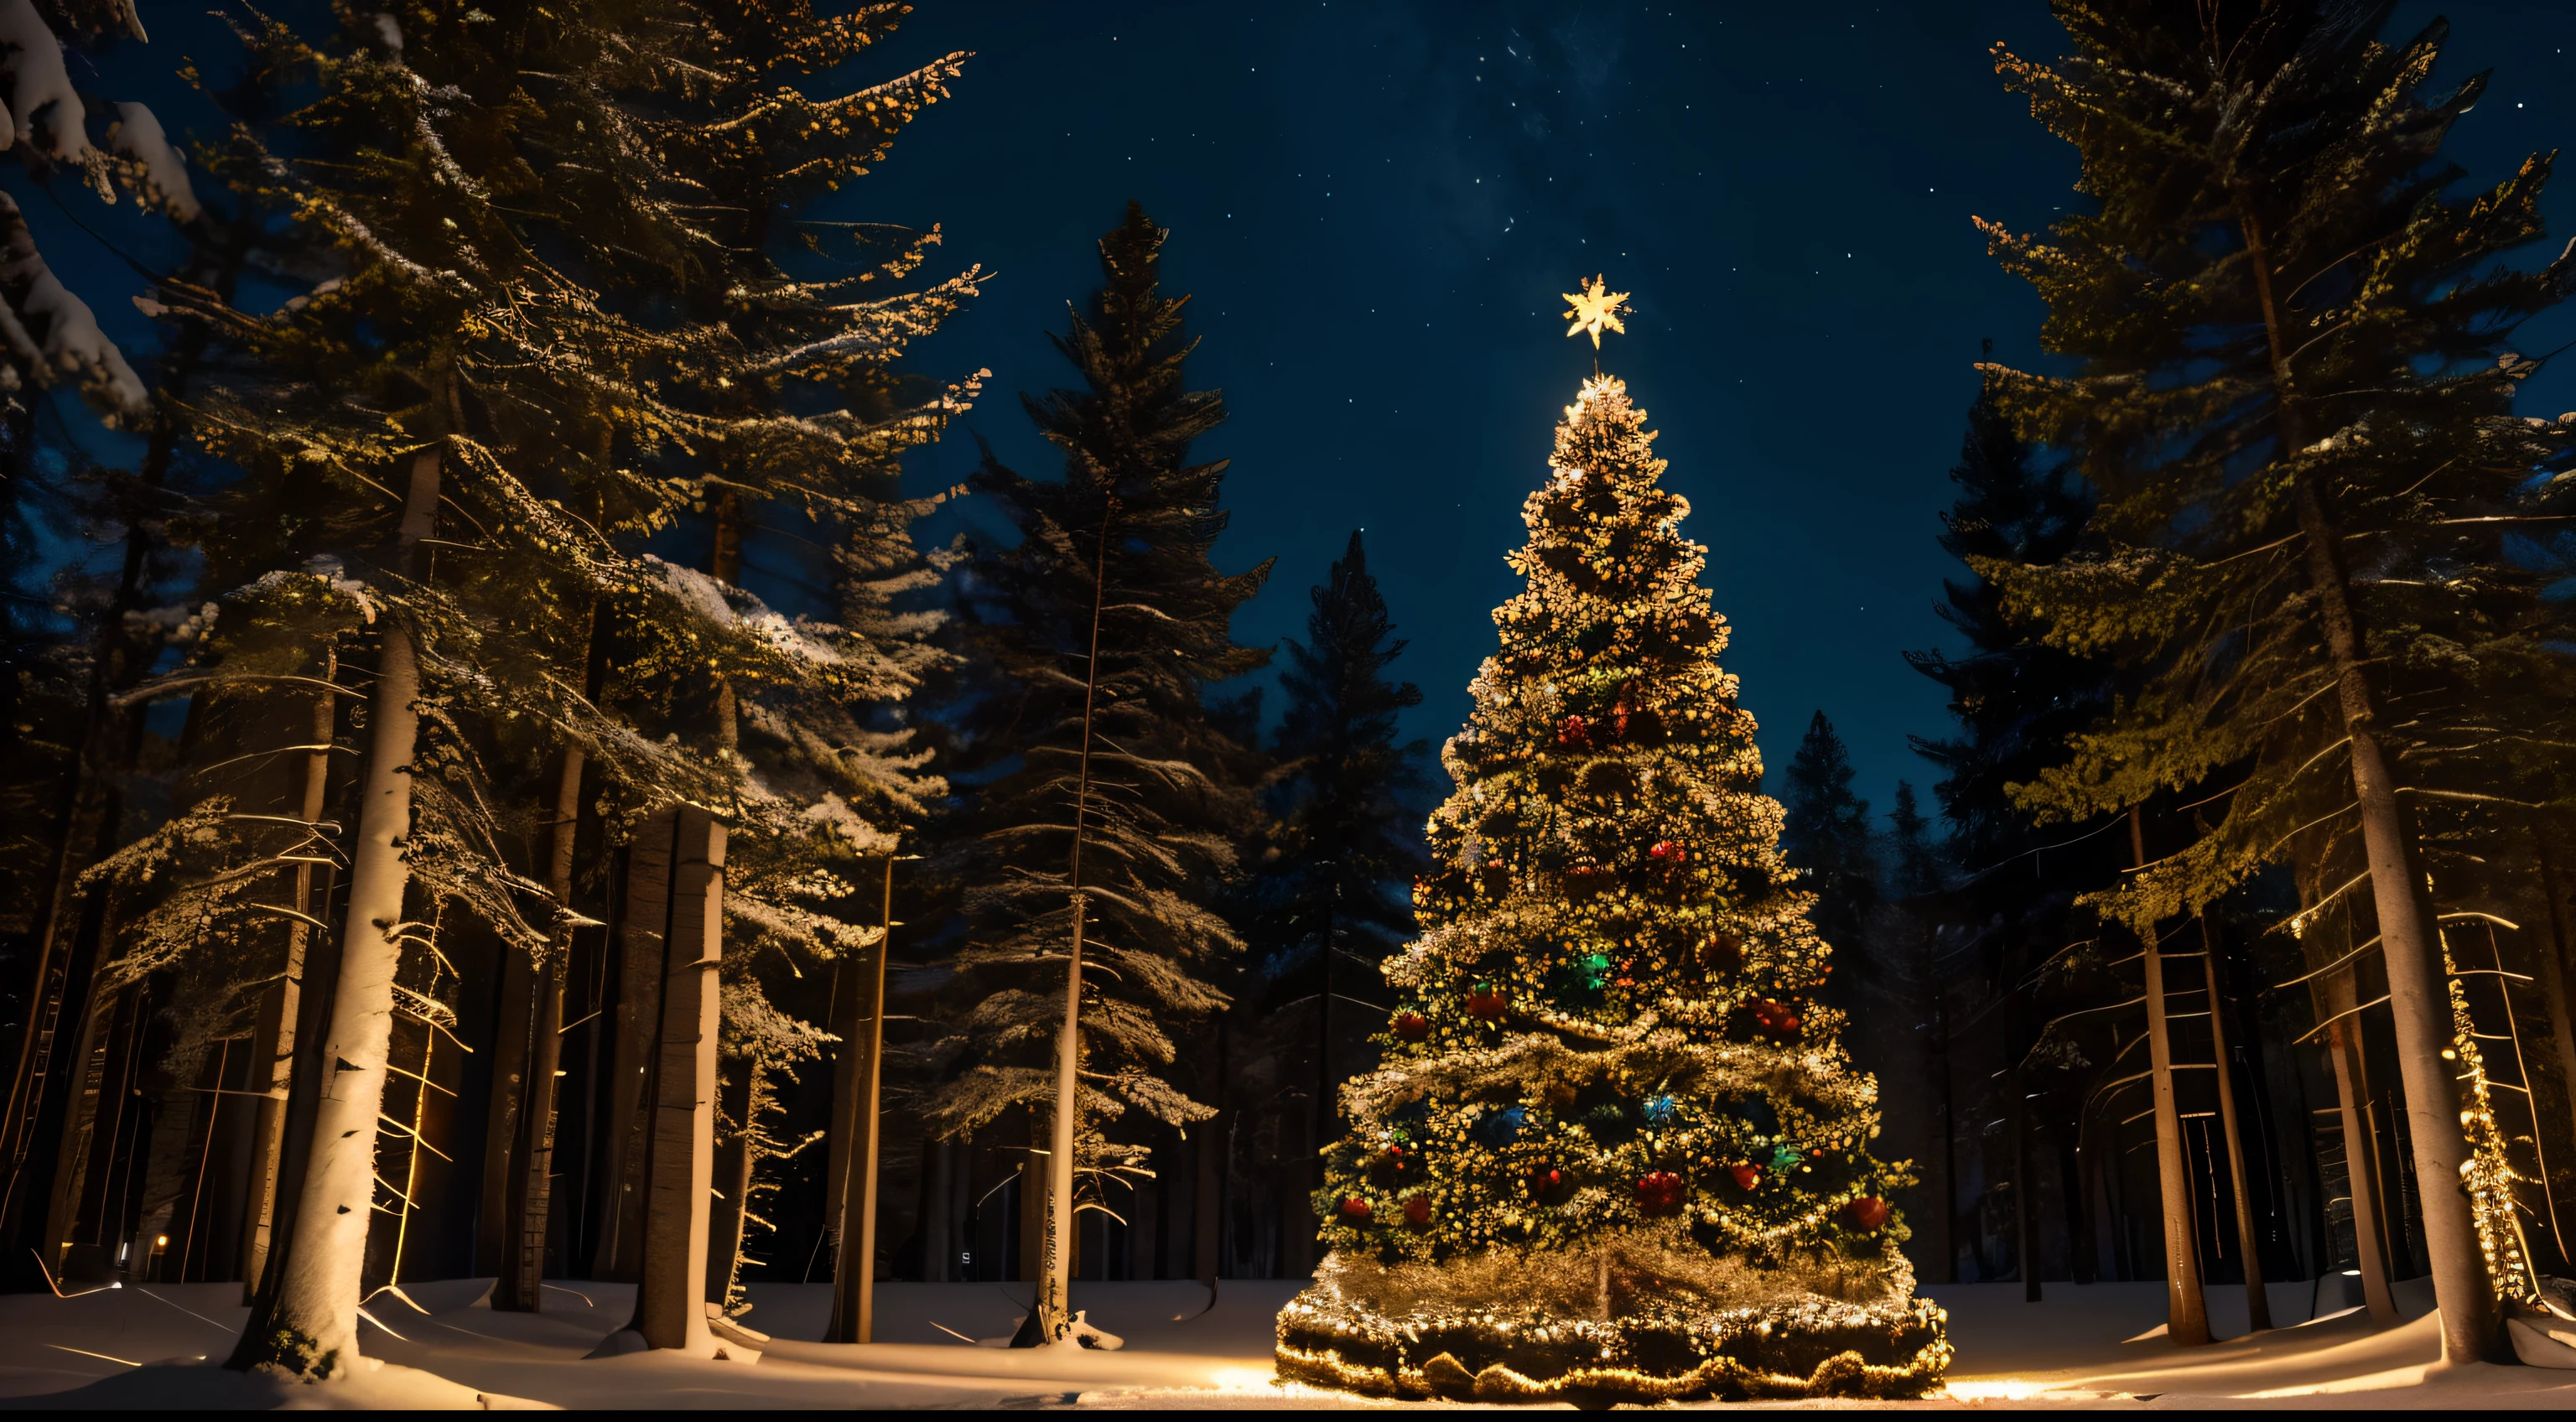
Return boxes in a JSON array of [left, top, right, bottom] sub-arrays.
[[0, 1280, 2576, 1409]]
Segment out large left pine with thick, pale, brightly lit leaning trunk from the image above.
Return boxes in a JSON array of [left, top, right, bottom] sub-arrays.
[[102, 8, 953, 1376]]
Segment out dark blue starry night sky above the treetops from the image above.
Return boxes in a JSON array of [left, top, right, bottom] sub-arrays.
[[35, 0, 2576, 812]]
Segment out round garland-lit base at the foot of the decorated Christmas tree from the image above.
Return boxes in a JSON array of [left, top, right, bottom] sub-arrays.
[[1278, 1283, 1950, 1404]]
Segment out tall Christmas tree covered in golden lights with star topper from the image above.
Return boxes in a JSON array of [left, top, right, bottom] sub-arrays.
[[1278, 283, 1950, 1401]]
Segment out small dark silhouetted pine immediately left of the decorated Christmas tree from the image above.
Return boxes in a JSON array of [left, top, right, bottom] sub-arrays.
[[1254, 531, 1430, 1272]]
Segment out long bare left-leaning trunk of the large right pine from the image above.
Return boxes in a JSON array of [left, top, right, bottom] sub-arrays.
[[2241, 204, 2511, 1362]]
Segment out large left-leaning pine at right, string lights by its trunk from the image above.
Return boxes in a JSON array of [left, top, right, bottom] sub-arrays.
[[1978, 0, 2568, 1357]]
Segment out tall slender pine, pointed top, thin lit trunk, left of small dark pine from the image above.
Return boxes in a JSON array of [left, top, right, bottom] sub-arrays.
[[930, 204, 1270, 1337]]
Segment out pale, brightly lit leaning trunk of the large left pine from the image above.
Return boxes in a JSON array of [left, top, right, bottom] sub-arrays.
[[226, 446, 440, 1378]]
